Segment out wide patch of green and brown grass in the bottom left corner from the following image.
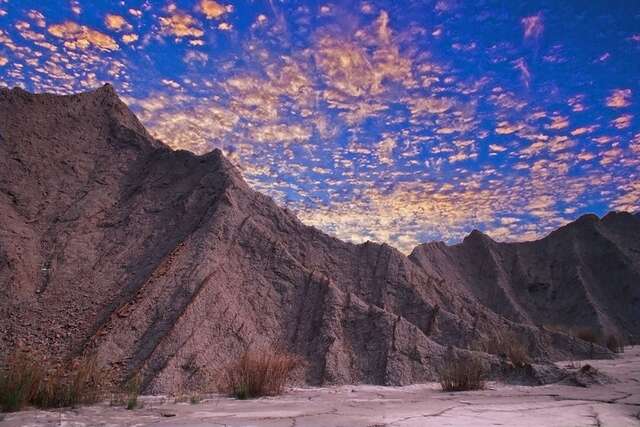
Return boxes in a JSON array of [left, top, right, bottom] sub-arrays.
[[0, 351, 104, 412]]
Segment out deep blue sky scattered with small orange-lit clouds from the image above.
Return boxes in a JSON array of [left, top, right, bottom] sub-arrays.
[[0, 0, 640, 252]]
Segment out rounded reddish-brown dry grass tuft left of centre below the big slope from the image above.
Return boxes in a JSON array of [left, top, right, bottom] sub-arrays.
[[221, 349, 301, 399]]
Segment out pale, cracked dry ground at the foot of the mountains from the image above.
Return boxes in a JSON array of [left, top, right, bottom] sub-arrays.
[[0, 347, 640, 427]]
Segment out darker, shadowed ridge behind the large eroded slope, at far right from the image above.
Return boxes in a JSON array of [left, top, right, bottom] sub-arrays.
[[410, 212, 640, 340]]
